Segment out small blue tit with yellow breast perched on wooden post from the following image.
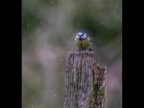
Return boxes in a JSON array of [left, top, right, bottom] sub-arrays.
[[75, 32, 91, 50]]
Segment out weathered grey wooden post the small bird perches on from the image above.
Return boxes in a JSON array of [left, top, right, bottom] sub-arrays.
[[64, 51, 106, 108]]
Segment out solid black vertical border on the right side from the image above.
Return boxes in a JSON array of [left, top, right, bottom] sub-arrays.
[[123, 0, 144, 108]]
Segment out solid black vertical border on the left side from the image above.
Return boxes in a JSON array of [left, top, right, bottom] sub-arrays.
[[0, 0, 22, 108]]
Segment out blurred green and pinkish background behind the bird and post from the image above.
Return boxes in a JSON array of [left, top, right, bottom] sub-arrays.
[[22, 0, 122, 108]]
